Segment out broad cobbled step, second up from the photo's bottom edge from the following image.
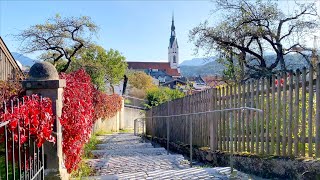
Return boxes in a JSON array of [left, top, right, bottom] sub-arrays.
[[85, 155, 190, 175]]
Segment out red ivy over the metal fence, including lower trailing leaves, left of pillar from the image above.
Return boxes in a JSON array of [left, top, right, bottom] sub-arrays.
[[0, 95, 55, 168]]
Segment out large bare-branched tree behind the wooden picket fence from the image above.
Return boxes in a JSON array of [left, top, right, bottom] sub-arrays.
[[190, 0, 319, 79]]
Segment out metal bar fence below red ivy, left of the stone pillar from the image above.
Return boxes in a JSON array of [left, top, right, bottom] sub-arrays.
[[0, 98, 44, 180]]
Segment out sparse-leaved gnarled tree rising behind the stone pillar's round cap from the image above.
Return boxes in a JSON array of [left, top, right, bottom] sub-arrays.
[[16, 15, 98, 72]]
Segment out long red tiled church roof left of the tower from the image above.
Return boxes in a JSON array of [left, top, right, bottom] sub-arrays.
[[127, 62, 180, 76]]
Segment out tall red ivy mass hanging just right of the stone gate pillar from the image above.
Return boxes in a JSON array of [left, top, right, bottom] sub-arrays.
[[60, 69, 94, 173]]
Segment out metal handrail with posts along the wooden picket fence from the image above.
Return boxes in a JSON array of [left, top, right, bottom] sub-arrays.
[[134, 107, 263, 174]]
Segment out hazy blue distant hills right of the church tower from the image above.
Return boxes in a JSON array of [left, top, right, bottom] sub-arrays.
[[180, 54, 308, 77]]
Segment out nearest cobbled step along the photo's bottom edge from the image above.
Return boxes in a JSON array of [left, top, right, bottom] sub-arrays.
[[78, 168, 228, 180]]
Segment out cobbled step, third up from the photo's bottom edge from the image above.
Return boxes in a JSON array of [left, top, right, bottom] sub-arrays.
[[91, 148, 167, 158]]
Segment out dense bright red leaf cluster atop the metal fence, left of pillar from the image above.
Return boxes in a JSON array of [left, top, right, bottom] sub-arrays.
[[0, 95, 55, 147]]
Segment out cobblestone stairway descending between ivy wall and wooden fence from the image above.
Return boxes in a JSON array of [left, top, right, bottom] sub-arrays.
[[85, 133, 248, 180]]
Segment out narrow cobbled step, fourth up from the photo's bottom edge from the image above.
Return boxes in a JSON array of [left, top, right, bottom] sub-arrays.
[[96, 143, 153, 150]]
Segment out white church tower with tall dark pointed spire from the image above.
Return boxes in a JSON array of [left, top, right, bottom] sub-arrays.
[[168, 15, 179, 69]]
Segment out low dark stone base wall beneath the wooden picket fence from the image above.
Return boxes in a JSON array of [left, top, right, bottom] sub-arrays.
[[147, 136, 320, 180]]
